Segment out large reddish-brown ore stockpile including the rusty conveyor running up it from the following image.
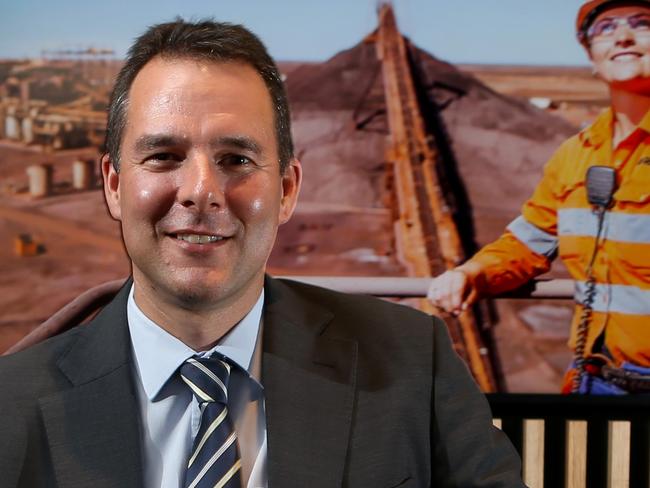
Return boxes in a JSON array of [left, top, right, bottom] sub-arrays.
[[272, 7, 576, 391]]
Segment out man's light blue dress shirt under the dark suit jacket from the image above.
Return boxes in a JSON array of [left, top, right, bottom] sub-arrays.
[[127, 287, 268, 488]]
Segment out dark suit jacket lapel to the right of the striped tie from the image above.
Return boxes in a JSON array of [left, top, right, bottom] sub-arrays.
[[262, 279, 357, 488]]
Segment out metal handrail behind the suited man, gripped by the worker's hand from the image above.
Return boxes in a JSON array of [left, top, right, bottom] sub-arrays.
[[4, 276, 574, 354]]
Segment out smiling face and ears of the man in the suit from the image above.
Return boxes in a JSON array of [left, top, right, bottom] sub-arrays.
[[102, 58, 301, 310]]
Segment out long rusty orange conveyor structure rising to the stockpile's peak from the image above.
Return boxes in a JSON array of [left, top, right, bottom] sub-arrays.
[[374, 4, 496, 392]]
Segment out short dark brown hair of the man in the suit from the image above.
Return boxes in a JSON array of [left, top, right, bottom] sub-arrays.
[[105, 18, 293, 172]]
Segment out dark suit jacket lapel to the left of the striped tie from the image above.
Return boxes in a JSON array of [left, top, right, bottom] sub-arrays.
[[39, 280, 142, 487]]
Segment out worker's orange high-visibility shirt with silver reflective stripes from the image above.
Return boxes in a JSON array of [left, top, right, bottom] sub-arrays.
[[471, 109, 650, 367]]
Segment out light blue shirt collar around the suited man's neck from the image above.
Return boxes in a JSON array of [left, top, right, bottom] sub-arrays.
[[127, 284, 264, 401]]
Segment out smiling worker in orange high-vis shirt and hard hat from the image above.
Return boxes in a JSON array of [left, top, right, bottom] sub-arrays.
[[429, 0, 650, 394]]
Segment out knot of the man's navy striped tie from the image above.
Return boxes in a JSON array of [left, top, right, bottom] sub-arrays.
[[181, 357, 231, 405]]
